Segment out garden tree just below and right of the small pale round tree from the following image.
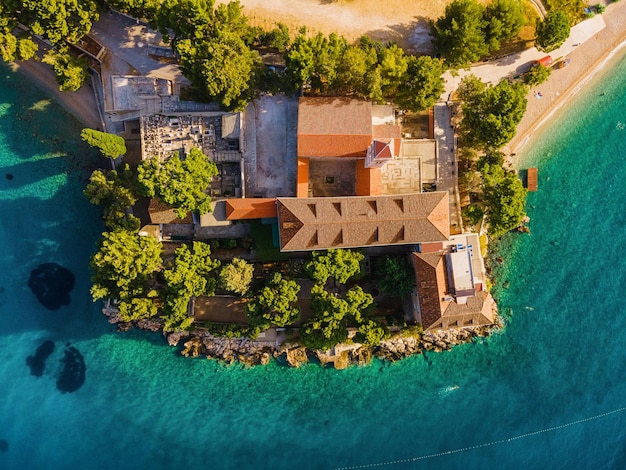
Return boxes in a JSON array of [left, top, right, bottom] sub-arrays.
[[246, 273, 300, 329]]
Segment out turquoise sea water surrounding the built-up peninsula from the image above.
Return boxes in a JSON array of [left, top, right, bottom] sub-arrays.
[[0, 50, 626, 469]]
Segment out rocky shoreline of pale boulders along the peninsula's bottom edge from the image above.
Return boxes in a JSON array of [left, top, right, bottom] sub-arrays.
[[102, 307, 502, 369]]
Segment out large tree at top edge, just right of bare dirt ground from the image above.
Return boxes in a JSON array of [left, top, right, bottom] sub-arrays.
[[431, 0, 489, 68]]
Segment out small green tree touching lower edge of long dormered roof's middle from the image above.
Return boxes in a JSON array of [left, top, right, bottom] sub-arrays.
[[304, 248, 364, 284]]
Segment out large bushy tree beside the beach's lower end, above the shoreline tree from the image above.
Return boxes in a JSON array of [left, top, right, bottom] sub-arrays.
[[459, 77, 527, 148]]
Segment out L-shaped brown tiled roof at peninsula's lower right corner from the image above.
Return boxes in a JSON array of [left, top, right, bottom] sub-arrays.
[[413, 252, 496, 330]]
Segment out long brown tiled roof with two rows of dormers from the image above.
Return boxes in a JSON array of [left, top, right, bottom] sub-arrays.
[[278, 192, 450, 251]]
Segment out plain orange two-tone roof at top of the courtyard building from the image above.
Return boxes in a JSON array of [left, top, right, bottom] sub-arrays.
[[298, 97, 372, 157]]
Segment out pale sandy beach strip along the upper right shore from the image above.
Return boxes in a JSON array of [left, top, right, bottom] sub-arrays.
[[503, 3, 626, 154]]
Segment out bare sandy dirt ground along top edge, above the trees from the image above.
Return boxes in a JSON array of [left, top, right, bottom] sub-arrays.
[[217, 0, 449, 52]]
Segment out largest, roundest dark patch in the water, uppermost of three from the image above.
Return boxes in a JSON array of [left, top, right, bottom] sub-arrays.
[[28, 263, 74, 310]]
